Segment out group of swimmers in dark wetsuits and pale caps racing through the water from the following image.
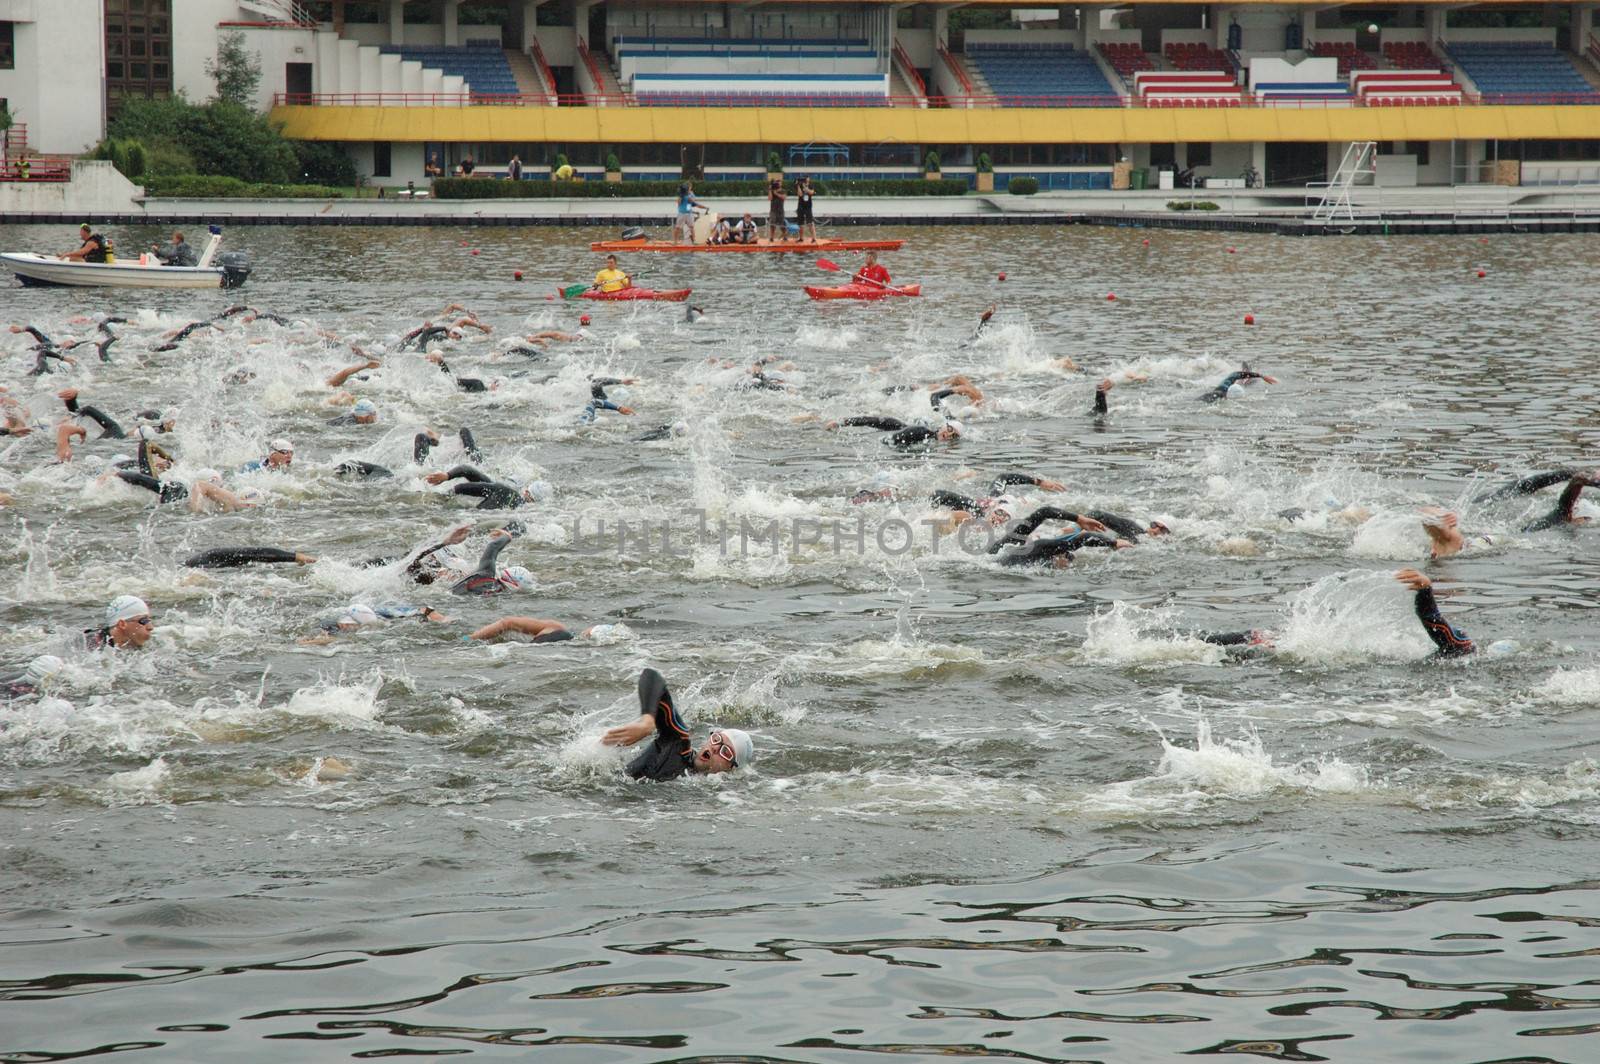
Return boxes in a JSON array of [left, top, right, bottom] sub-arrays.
[[0, 265, 1600, 779]]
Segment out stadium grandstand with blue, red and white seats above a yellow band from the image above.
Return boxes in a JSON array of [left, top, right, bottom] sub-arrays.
[[9, 0, 1600, 189]]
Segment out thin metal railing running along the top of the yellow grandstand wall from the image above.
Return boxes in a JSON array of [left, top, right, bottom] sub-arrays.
[[272, 91, 1600, 110]]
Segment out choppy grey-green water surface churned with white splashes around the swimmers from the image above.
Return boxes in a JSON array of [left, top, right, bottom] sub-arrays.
[[0, 219, 1600, 1061]]
